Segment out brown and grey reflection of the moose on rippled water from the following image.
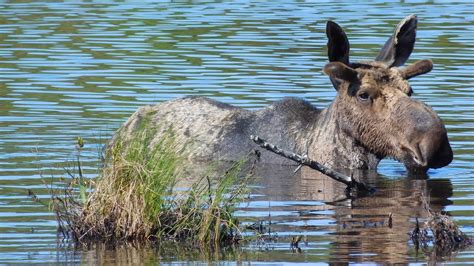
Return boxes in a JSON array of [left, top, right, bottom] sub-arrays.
[[255, 166, 453, 263]]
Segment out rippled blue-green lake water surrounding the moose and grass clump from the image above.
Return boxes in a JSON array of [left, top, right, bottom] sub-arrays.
[[0, 1, 474, 263]]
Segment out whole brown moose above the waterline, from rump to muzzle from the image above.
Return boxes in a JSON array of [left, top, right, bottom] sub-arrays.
[[111, 15, 453, 171]]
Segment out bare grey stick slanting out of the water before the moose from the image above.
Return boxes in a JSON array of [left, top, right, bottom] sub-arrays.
[[250, 135, 372, 191]]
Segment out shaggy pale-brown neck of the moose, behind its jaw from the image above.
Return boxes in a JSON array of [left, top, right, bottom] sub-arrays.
[[305, 99, 380, 169]]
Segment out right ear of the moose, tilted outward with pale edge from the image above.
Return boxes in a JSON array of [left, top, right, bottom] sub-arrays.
[[375, 15, 417, 67]]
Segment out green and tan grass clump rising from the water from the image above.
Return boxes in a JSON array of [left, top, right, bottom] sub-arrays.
[[53, 121, 253, 246]]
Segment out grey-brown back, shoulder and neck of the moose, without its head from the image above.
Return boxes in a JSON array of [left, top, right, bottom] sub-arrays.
[[108, 97, 378, 168]]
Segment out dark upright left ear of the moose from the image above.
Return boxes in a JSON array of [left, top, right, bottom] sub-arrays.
[[326, 21, 349, 65]]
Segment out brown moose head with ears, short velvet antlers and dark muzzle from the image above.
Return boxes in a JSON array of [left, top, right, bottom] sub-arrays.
[[324, 15, 453, 171]]
